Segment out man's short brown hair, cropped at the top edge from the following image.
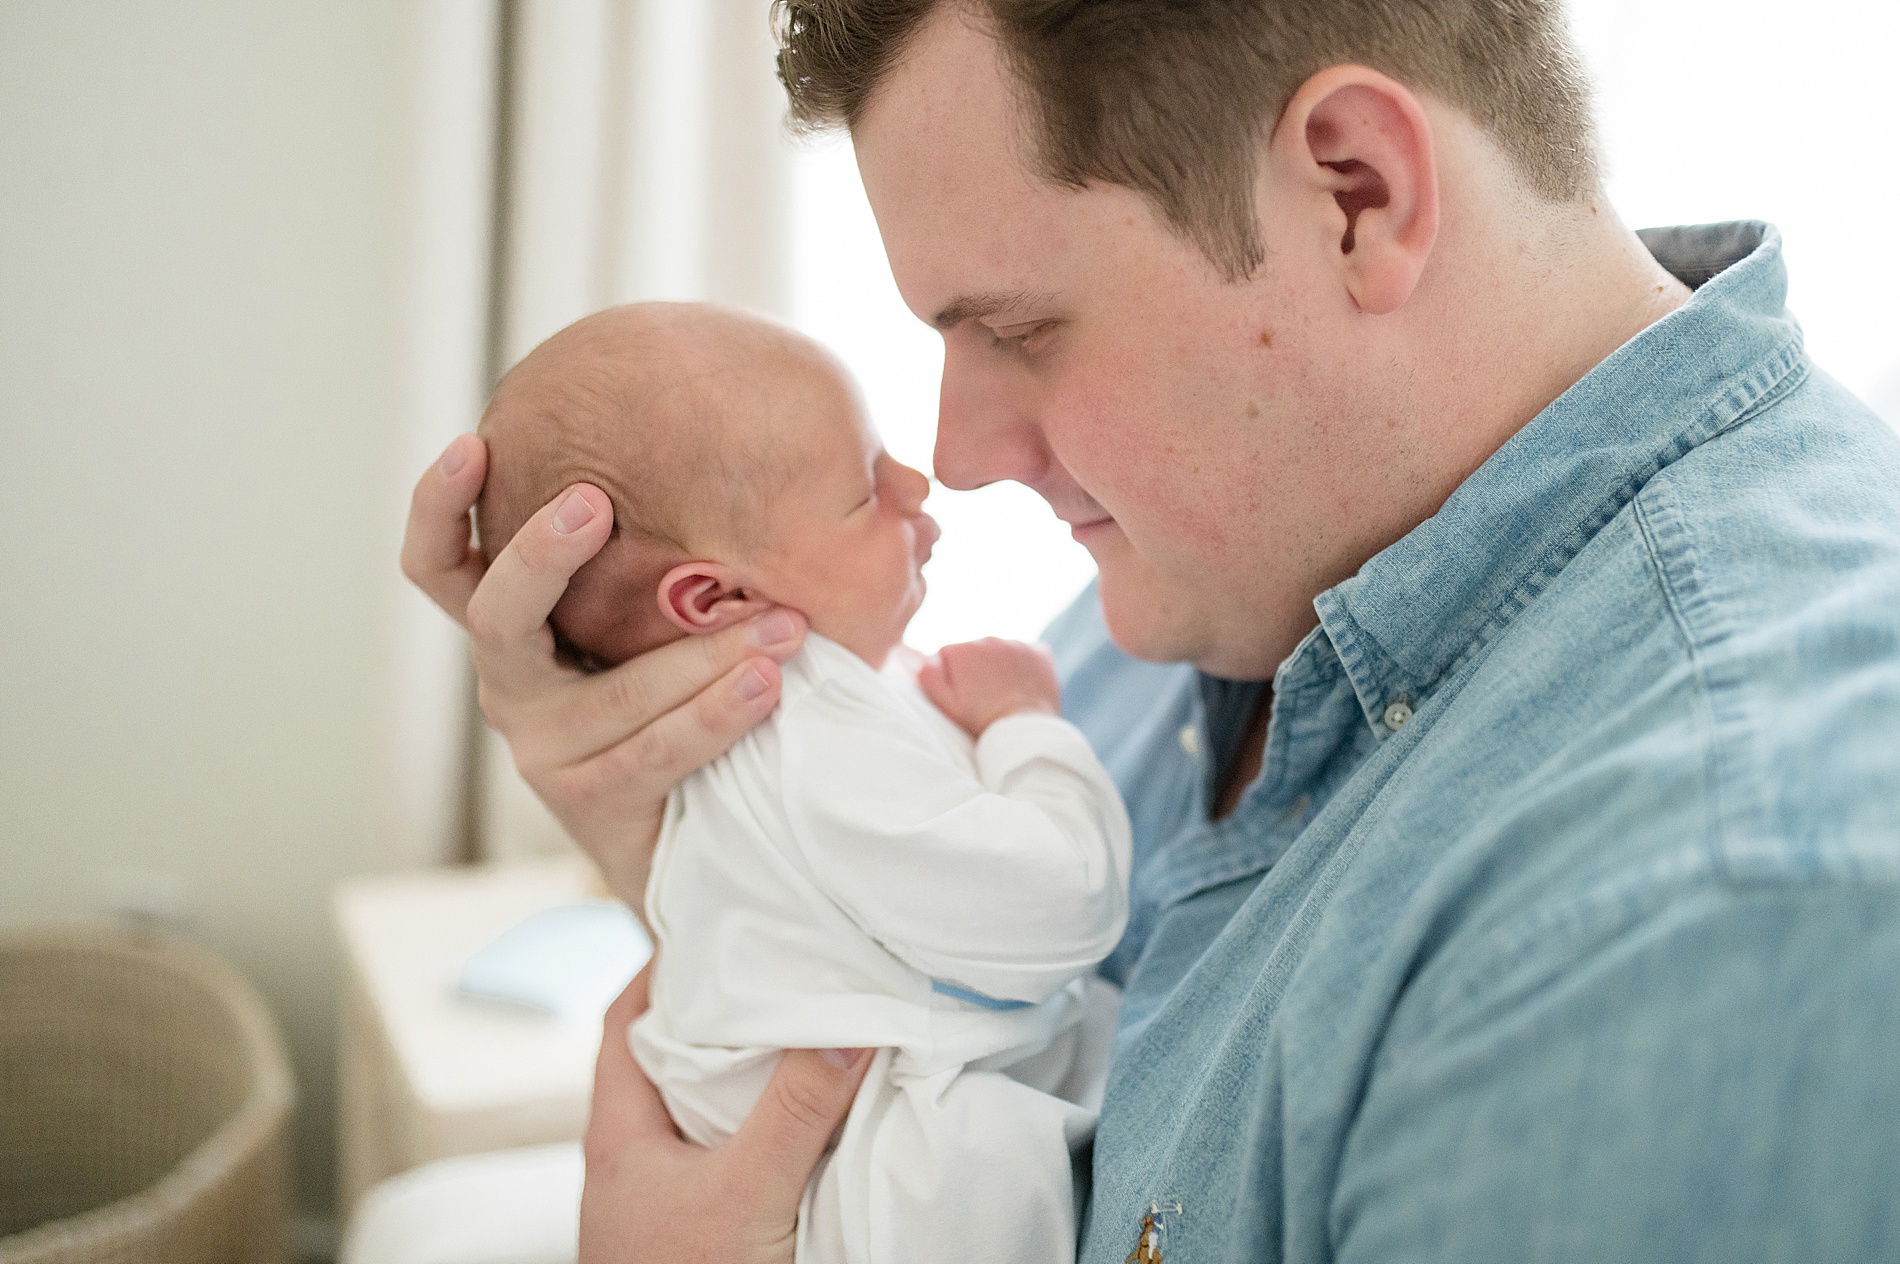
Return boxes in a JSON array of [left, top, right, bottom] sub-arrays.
[[773, 0, 1598, 279]]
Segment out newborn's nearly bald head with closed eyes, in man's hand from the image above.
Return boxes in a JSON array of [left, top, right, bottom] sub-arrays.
[[475, 302, 937, 667]]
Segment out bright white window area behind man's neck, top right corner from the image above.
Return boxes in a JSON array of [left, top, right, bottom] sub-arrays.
[[1571, 0, 1900, 406]]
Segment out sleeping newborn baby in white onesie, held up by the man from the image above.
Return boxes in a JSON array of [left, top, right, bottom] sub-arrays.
[[477, 304, 1129, 1264]]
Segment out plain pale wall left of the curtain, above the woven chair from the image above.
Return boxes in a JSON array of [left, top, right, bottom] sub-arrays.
[[0, 0, 459, 1231]]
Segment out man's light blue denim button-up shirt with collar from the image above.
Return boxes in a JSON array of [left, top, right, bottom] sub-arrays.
[[1051, 224, 1900, 1264]]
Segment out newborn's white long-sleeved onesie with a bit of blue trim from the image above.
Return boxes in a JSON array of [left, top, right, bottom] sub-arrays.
[[629, 635, 1129, 1264]]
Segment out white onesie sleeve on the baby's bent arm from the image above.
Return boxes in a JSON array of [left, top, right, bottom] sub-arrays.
[[779, 682, 1129, 1002]]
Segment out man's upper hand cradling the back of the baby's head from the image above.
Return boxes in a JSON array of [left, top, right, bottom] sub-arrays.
[[403, 435, 806, 909]]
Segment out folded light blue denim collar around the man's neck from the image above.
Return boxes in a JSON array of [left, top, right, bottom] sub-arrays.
[[1314, 222, 1805, 739]]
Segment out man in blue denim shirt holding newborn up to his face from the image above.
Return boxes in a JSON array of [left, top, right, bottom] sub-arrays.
[[407, 0, 1900, 1264]]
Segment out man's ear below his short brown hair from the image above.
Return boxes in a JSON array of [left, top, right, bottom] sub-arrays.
[[1271, 67, 1438, 316]]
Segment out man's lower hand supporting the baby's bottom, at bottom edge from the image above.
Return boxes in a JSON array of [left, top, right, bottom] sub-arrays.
[[580, 967, 872, 1264]]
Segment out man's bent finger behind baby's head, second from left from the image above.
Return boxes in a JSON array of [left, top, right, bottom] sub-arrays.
[[467, 483, 614, 696]]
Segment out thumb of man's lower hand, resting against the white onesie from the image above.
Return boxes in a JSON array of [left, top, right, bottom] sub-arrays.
[[724, 1049, 876, 1209]]
